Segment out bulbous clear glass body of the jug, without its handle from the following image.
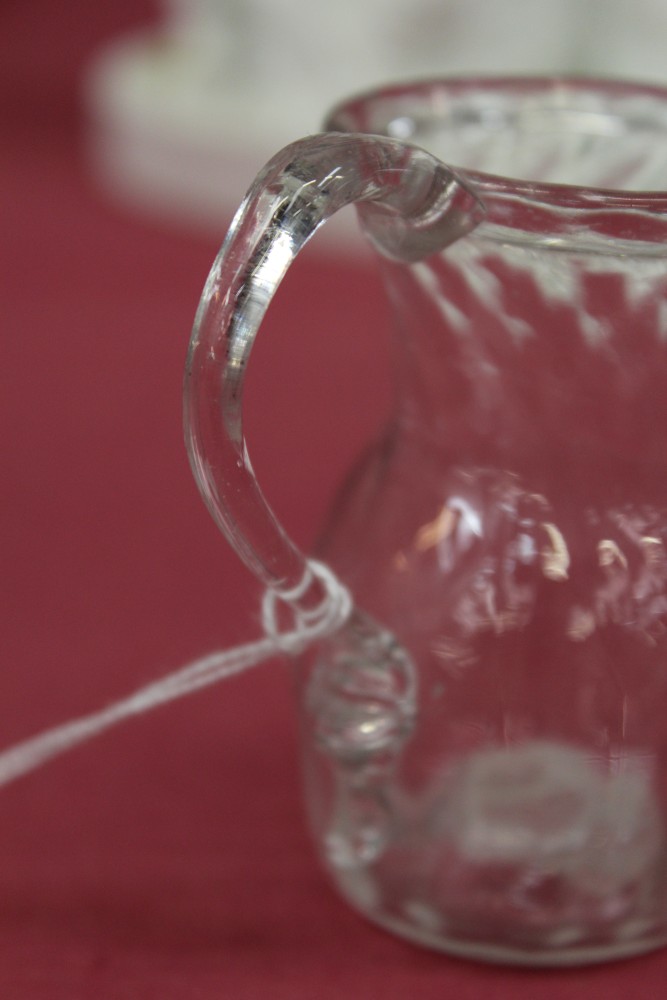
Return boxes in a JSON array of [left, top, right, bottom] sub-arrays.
[[303, 76, 667, 962]]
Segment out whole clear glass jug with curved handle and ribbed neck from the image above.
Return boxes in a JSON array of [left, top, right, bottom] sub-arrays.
[[186, 79, 667, 964]]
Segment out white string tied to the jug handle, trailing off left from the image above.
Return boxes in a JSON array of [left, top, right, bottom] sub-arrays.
[[0, 560, 353, 786]]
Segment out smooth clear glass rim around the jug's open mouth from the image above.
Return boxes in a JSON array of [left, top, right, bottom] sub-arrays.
[[324, 74, 667, 217]]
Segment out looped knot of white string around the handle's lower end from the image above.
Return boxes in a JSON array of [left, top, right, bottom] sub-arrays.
[[262, 559, 353, 656]]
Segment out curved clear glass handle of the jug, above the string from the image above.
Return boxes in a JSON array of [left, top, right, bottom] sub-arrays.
[[184, 133, 483, 611]]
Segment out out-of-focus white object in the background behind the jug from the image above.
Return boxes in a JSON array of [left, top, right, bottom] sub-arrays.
[[85, 0, 667, 243]]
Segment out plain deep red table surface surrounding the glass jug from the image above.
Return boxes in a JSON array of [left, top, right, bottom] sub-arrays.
[[5, 0, 667, 1000]]
